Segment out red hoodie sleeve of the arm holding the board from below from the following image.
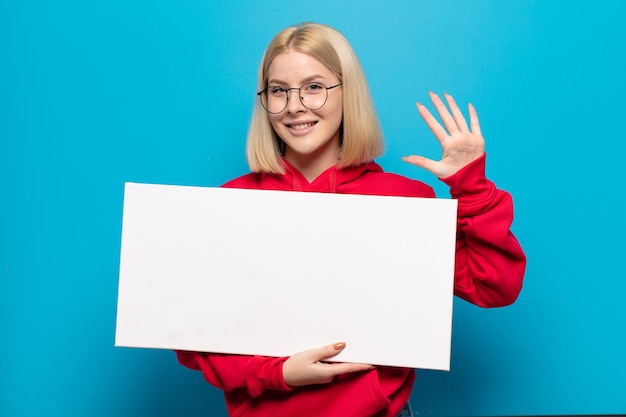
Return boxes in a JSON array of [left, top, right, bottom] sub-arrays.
[[176, 351, 293, 398]]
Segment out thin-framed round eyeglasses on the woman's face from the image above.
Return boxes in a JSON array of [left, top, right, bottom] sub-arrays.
[[256, 82, 341, 114]]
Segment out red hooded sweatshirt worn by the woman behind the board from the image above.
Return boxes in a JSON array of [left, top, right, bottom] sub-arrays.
[[177, 156, 526, 417]]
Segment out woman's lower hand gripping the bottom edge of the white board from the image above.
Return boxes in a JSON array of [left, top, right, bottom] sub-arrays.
[[283, 343, 374, 387]]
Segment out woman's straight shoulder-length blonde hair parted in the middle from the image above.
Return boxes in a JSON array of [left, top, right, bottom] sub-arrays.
[[246, 23, 384, 174]]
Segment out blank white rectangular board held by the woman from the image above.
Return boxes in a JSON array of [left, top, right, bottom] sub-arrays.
[[115, 183, 457, 370]]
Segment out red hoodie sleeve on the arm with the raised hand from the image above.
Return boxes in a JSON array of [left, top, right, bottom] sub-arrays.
[[441, 155, 526, 307]]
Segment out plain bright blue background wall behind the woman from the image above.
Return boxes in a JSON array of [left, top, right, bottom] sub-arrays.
[[0, 0, 626, 416]]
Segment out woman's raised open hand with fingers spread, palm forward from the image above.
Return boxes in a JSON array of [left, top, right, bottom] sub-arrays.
[[402, 92, 485, 178]]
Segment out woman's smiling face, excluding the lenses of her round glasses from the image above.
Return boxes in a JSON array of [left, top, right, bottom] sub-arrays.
[[268, 51, 343, 169]]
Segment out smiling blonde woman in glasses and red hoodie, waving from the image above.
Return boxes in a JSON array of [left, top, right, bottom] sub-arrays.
[[177, 23, 526, 417]]
